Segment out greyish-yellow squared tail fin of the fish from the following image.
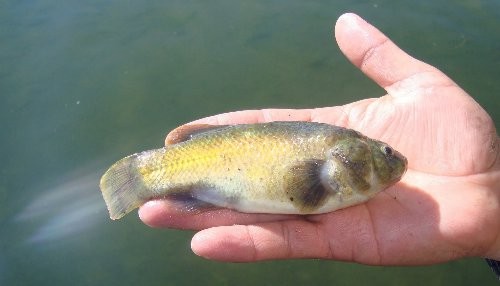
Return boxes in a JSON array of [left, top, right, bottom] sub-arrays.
[[100, 154, 152, 220]]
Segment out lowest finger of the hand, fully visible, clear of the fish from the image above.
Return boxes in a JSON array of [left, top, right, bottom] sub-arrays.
[[191, 203, 380, 264]]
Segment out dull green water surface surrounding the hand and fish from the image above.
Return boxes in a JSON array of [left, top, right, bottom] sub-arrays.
[[0, 0, 500, 285]]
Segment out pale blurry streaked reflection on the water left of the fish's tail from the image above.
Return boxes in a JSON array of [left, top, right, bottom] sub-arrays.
[[14, 164, 106, 244]]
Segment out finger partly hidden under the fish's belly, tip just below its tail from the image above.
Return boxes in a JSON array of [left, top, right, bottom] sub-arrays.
[[139, 200, 297, 230]]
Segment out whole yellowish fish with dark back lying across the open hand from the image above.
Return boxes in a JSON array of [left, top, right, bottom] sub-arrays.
[[100, 121, 408, 220]]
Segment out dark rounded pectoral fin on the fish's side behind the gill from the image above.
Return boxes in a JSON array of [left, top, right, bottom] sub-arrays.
[[284, 160, 331, 212]]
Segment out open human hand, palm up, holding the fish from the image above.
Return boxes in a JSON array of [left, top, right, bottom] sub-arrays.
[[139, 14, 500, 265]]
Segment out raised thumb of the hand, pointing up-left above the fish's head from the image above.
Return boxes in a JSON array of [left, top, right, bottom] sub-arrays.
[[335, 13, 454, 95]]
